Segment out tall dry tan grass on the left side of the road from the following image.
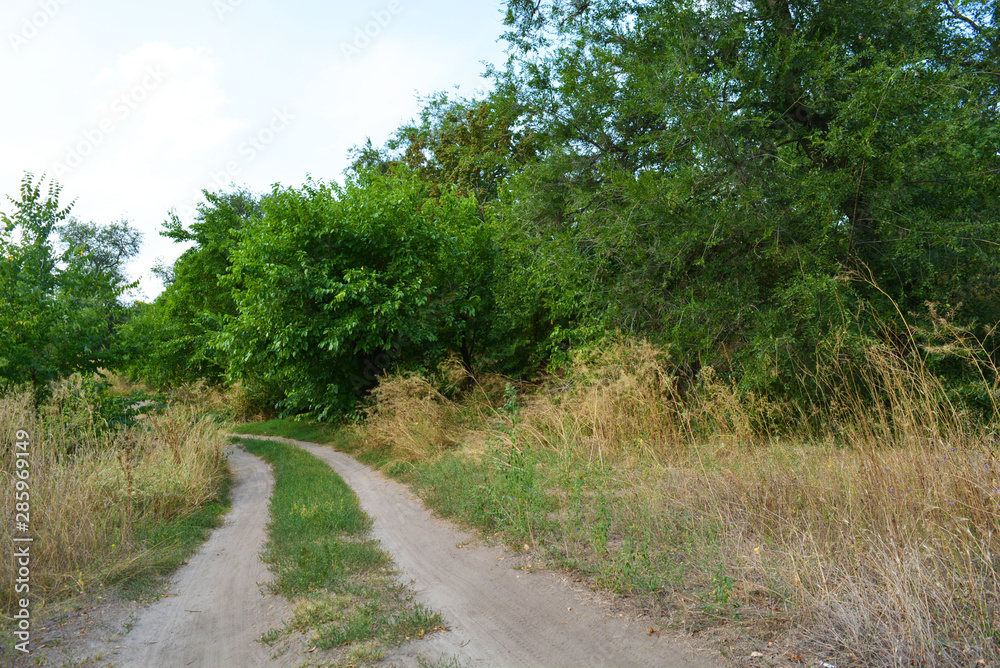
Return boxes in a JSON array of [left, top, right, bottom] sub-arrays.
[[0, 378, 227, 610]]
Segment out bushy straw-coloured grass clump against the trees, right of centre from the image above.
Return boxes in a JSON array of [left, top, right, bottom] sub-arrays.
[[519, 339, 785, 461]]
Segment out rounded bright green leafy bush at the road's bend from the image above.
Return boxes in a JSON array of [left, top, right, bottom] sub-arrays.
[[221, 171, 490, 418]]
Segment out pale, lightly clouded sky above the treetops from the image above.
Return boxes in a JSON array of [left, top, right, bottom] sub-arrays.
[[0, 0, 504, 299]]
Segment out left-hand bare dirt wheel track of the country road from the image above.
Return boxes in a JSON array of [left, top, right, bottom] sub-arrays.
[[24, 449, 292, 668]]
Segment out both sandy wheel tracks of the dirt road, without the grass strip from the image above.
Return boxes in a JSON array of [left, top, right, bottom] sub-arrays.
[[25, 439, 726, 668]]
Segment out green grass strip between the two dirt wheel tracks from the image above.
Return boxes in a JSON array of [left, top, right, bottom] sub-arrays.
[[240, 436, 443, 665]]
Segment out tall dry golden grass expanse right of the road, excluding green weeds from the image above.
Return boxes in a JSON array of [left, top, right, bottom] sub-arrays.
[[356, 340, 1000, 666]]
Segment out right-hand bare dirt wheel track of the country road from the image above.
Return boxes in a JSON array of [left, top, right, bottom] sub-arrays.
[[236, 439, 727, 668]]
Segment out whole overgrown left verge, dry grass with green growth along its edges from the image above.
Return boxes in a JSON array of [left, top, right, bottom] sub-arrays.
[[0, 375, 229, 615]]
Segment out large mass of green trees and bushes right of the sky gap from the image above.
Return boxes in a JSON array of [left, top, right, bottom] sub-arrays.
[[117, 0, 1000, 418]]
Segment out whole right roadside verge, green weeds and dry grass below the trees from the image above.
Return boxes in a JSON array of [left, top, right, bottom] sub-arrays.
[[236, 342, 1000, 666]]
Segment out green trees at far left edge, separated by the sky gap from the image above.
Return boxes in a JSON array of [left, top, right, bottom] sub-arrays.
[[0, 174, 140, 389]]
